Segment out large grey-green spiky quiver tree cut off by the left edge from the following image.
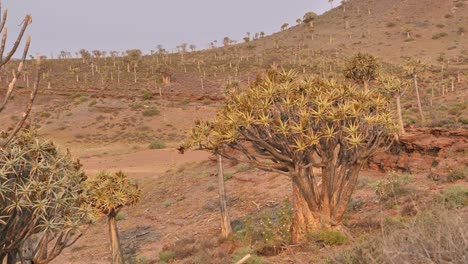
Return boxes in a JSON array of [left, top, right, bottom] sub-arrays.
[[0, 132, 89, 264]]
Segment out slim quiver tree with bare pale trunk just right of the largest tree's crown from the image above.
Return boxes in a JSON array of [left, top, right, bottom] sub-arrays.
[[378, 74, 409, 136]]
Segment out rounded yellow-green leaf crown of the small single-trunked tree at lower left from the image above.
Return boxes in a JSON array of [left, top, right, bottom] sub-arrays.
[[87, 171, 140, 215]]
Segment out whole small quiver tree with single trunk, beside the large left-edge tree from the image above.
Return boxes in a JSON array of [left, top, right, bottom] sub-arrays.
[[87, 172, 140, 264]]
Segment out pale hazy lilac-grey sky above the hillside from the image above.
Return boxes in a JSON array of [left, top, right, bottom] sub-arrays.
[[2, 0, 332, 55]]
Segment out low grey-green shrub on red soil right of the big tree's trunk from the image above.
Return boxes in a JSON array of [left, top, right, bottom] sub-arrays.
[[374, 173, 412, 201]]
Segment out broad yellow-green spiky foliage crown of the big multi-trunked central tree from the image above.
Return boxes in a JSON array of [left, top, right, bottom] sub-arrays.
[[186, 70, 396, 162]]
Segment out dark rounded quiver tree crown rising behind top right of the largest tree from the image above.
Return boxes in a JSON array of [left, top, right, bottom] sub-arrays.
[[344, 52, 380, 91]]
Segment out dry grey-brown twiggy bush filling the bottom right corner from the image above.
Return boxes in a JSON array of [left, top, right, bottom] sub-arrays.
[[328, 208, 468, 264]]
